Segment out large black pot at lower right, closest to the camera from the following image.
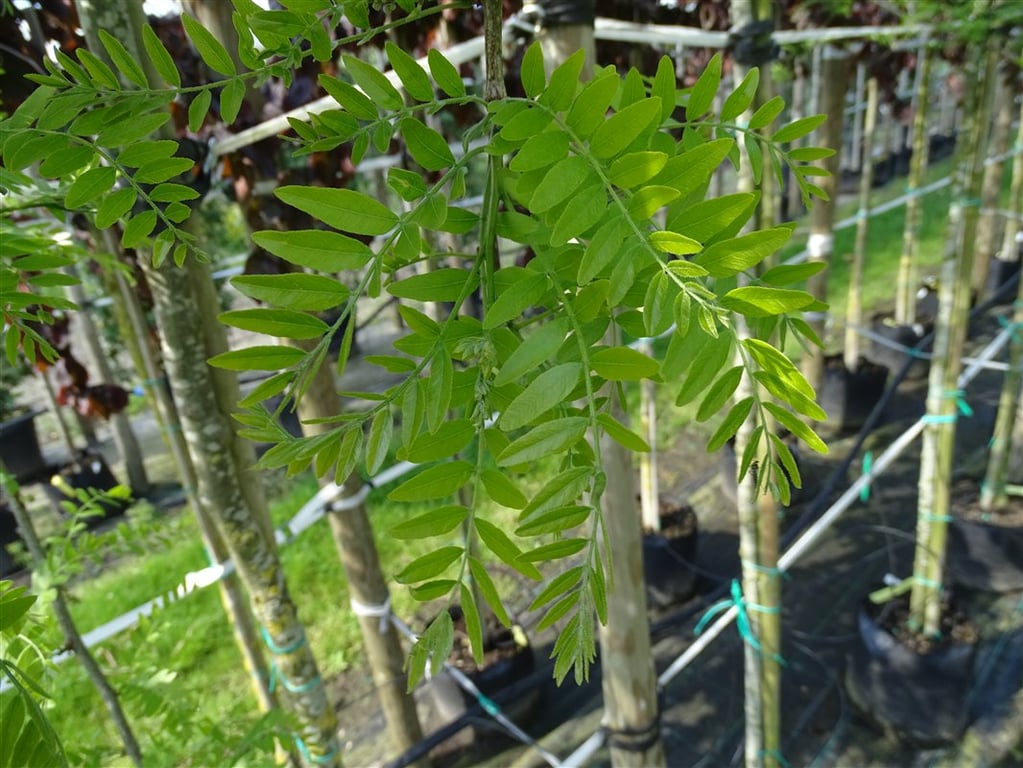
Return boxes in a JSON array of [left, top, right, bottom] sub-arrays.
[[845, 597, 977, 748]]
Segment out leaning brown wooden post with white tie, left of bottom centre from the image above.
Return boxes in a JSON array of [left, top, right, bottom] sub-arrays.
[[285, 340, 422, 757]]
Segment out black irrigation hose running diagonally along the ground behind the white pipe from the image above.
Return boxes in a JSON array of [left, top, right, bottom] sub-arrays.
[[385, 273, 1020, 768]]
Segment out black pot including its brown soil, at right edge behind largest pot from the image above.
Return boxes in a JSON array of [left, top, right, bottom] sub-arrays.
[[946, 484, 1023, 592]]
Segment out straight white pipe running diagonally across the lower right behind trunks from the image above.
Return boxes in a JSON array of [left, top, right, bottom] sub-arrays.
[[562, 328, 1013, 768]]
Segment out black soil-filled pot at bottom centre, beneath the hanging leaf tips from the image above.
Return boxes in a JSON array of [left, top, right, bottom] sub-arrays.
[[429, 605, 539, 722]]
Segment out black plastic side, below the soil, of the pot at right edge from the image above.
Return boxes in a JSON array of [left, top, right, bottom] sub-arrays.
[[946, 521, 1023, 592]]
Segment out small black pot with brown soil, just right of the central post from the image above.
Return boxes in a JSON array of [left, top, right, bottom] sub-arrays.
[[642, 499, 697, 609]]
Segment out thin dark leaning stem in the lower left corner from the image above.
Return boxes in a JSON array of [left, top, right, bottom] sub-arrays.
[[9, 491, 142, 766]]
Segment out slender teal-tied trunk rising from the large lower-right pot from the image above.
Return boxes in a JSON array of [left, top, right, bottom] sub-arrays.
[[909, 34, 997, 637]]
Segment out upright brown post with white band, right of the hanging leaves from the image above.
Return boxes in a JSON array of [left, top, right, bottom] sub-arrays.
[[801, 46, 849, 390]]
